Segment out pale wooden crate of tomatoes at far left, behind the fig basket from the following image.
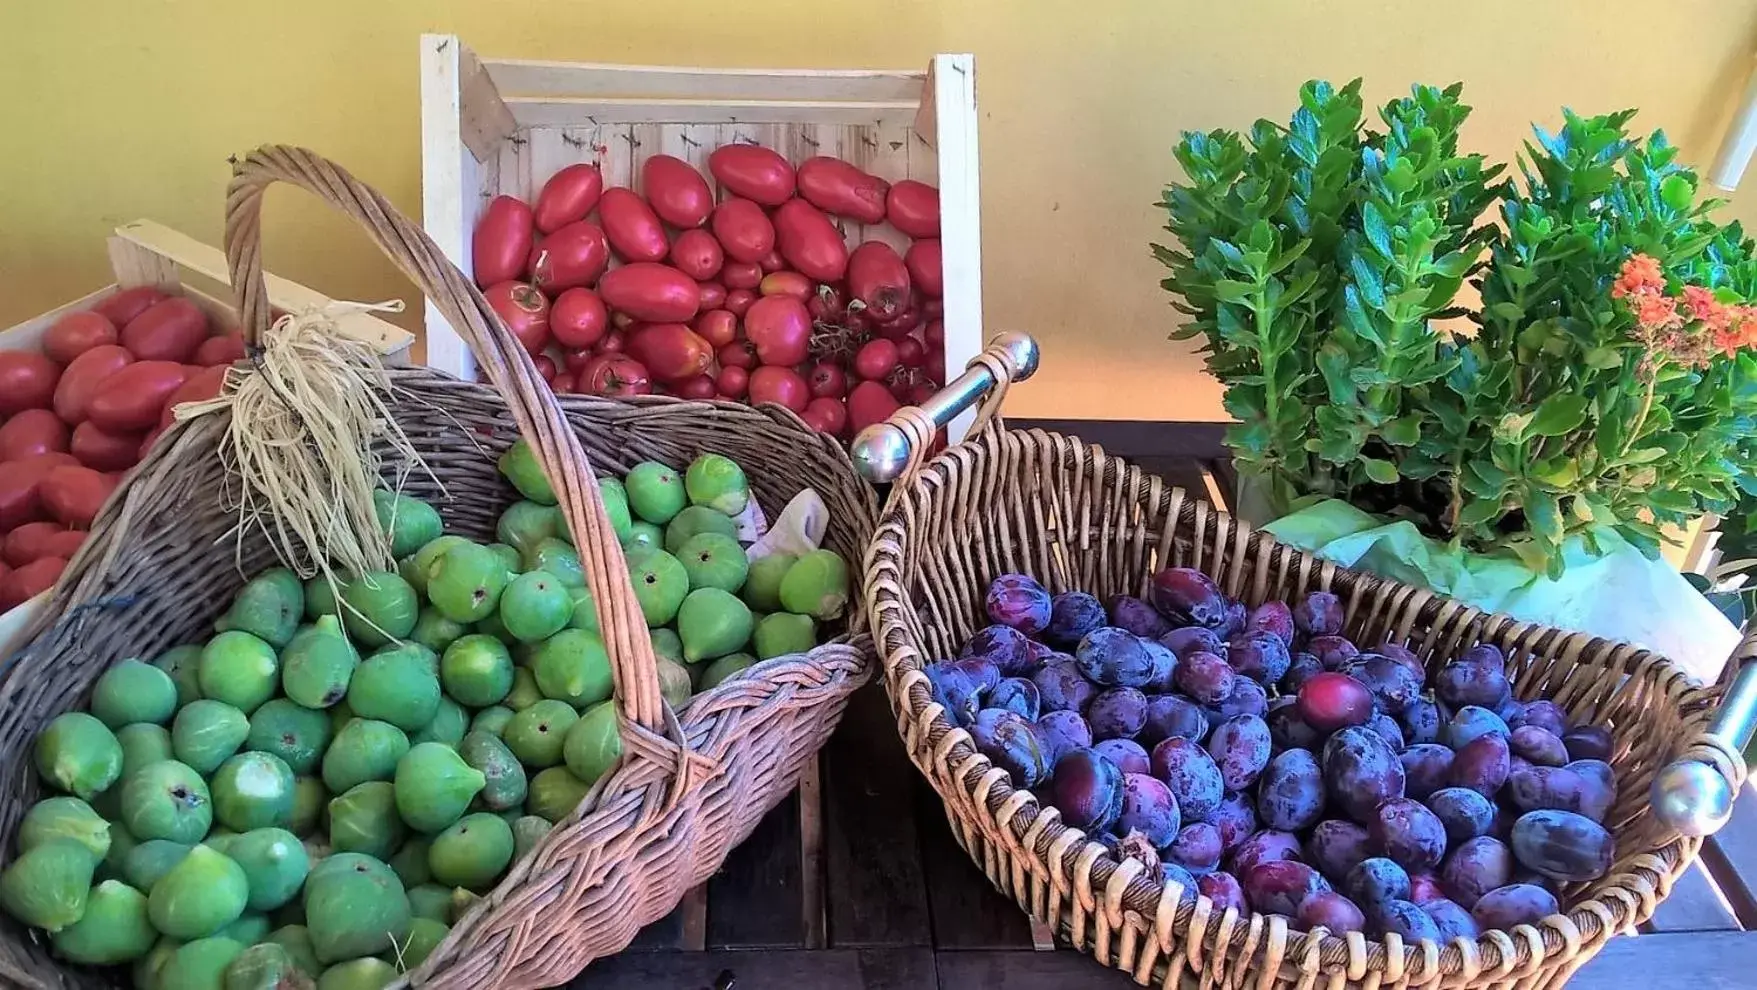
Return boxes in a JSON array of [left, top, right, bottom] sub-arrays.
[[0, 220, 415, 656]]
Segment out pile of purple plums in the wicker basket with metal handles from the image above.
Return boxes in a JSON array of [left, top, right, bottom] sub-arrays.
[[928, 568, 1616, 943]]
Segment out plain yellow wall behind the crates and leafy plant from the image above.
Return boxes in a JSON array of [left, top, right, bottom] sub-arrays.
[[0, 0, 1757, 419]]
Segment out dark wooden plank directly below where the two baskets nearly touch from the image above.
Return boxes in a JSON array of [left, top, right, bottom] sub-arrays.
[[822, 682, 931, 948]]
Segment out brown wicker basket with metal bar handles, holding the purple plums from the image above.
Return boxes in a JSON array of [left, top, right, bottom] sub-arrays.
[[866, 341, 1748, 988]]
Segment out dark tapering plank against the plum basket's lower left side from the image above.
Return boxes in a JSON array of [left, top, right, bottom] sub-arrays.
[[915, 781, 1031, 950]]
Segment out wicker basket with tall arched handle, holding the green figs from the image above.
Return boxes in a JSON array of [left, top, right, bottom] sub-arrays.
[[0, 148, 877, 988]]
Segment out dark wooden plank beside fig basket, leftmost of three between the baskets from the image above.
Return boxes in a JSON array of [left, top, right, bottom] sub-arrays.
[[708, 791, 805, 950]]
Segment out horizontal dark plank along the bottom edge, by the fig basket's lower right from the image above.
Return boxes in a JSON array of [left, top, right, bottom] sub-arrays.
[[569, 948, 936, 990]]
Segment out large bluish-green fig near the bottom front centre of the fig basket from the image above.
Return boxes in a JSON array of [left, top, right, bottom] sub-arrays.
[[306, 853, 409, 972]]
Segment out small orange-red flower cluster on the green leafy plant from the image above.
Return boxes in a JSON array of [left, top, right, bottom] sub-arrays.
[[1611, 253, 1757, 368]]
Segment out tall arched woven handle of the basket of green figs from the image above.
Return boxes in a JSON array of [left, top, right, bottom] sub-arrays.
[[225, 144, 685, 745]]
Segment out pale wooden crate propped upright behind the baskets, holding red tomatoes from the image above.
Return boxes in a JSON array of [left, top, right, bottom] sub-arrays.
[[422, 35, 982, 434]]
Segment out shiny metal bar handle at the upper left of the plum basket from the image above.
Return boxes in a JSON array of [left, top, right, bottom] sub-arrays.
[[850, 332, 1038, 484]]
